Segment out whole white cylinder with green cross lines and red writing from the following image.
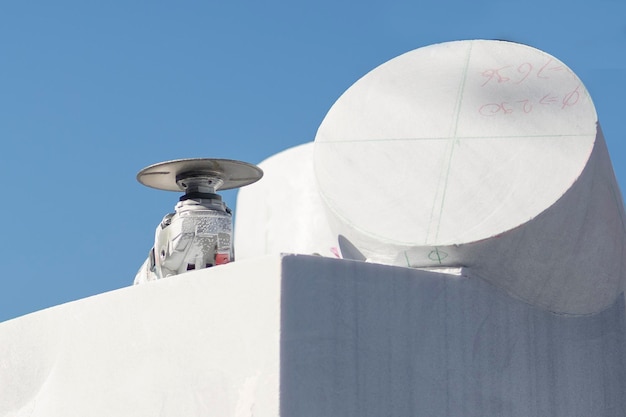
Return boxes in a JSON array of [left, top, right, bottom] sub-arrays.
[[314, 40, 626, 314]]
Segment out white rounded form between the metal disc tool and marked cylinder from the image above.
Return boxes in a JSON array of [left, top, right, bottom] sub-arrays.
[[234, 142, 337, 260]]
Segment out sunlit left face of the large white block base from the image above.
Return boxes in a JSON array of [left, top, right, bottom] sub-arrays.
[[0, 257, 280, 417]]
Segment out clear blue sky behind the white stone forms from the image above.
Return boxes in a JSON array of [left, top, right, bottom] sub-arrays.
[[0, 0, 626, 321]]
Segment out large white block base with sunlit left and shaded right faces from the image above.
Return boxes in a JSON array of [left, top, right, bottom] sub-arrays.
[[0, 255, 626, 417]]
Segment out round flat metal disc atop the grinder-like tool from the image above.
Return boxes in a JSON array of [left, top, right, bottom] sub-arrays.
[[137, 158, 263, 191]]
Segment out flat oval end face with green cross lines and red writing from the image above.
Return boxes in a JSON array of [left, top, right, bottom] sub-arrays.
[[314, 40, 597, 246]]
